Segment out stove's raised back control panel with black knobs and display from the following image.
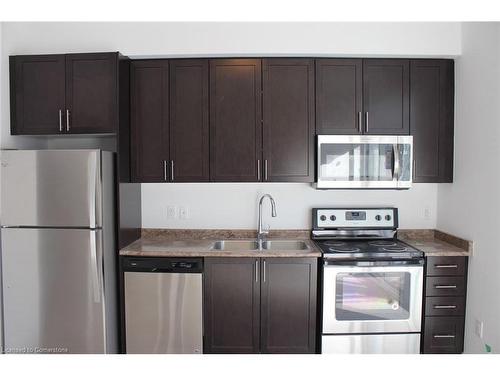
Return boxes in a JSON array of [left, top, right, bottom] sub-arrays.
[[313, 208, 398, 228]]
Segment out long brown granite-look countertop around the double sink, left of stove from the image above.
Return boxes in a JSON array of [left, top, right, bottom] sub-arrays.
[[120, 229, 321, 258]]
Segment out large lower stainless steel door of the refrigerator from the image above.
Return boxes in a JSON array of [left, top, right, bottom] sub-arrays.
[[1, 228, 106, 353]]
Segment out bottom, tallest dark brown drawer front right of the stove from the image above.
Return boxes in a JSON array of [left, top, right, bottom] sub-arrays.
[[422, 317, 464, 354]]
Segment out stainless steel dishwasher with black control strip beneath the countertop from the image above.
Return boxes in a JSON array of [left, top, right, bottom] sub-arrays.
[[122, 258, 203, 354]]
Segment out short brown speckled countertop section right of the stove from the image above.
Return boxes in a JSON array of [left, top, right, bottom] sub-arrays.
[[398, 229, 473, 256]]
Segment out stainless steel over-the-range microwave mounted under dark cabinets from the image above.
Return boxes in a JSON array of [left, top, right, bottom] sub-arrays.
[[316, 135, 413, 189]]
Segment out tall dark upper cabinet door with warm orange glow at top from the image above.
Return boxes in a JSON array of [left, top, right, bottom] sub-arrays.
[[210, 59, 262, 181]]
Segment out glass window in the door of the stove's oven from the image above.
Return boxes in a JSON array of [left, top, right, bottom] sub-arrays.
[[335, 272, 411, 321]]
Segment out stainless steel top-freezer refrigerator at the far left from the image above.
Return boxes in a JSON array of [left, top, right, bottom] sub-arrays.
[[0, 150, 118, 353]]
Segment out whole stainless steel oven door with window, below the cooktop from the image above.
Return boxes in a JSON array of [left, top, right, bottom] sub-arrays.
[[323, 262, 423, 334]]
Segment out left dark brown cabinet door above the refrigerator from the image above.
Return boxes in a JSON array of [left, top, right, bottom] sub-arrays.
[[10, 55, 65, 135]]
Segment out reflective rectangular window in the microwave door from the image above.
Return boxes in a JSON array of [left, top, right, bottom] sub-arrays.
[[319, 143, 394, 181]]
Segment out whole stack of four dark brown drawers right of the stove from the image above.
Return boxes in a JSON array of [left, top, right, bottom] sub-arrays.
[[422, 256, 467, 353]]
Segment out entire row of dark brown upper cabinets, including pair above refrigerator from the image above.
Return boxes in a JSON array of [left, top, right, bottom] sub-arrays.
[[10, 53, 454, 182]]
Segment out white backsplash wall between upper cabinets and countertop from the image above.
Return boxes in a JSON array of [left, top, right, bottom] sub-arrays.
[[142, 183, 437, 229]]
